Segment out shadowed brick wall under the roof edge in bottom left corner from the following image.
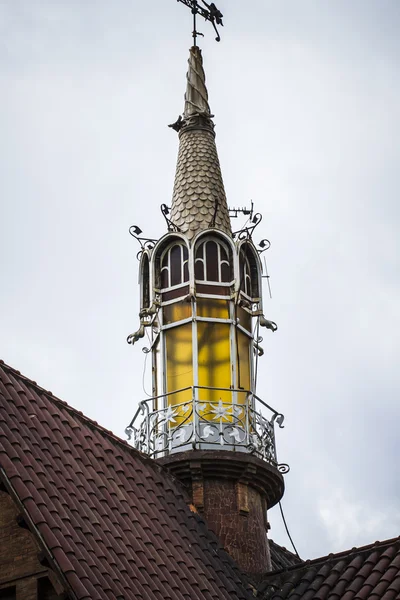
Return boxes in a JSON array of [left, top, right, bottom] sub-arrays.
[[0, 490, 58, 600]]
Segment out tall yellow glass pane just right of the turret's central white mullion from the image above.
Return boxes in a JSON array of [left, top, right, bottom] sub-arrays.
[[197, 322, 232, 422]]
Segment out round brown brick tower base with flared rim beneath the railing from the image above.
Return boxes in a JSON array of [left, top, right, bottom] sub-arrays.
[[157, 450, 284, 574]]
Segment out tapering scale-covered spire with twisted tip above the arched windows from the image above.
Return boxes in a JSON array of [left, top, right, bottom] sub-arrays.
[[171, 46, 232, 239]]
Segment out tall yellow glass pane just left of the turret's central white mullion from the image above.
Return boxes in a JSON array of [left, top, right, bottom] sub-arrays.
[[165, 323, 193, 420]]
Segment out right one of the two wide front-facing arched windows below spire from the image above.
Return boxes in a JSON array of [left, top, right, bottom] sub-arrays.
[[194, 238, 233, 283]]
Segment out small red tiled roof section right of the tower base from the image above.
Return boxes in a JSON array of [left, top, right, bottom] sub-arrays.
[[258, 538, 400, 600]]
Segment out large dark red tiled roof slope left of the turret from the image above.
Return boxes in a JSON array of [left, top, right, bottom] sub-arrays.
[[0, 363, 253, 600]]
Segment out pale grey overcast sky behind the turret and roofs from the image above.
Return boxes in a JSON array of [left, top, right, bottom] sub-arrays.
[[0, 0, 400, 558]]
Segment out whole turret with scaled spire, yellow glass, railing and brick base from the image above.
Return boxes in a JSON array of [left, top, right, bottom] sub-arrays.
[[127, 47, 287, 573]]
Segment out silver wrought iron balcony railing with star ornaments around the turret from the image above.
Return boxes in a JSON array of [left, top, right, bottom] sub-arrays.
[[125, 386, 287, 472]]
